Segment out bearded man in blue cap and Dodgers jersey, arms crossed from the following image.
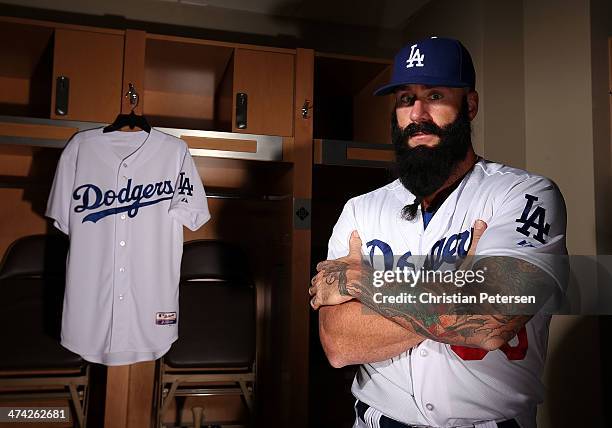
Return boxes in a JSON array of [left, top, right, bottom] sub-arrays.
[[309, 38, 567, 428]]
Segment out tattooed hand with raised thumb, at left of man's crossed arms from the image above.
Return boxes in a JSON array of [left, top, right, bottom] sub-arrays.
[[308, 230, 373, 310]]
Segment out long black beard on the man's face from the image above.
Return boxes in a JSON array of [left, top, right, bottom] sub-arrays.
[[391, 97, 472, 220]]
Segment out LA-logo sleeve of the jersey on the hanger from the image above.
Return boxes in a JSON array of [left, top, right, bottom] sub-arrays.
[[168, 146, 210, 230]]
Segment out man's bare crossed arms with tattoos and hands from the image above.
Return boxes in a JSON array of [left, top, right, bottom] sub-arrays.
[[309, 220, 556, 366]]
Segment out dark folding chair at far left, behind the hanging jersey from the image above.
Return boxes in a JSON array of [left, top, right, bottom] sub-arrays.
[[0, 235, 89, 427]]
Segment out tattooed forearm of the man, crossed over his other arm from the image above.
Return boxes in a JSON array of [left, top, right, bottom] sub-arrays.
[[347, 257, 556, 349]]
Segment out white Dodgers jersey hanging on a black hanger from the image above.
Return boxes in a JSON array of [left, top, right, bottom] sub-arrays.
[[46, 128, 210, 365]]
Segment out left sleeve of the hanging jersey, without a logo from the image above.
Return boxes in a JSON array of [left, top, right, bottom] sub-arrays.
[[45, 134, 79, 235]]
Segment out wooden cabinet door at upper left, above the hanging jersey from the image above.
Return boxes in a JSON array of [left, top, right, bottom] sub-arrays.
[[51, 29, 124, 123]]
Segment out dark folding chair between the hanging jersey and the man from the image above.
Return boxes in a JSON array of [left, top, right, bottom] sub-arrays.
[[158, 240, 256, 427]]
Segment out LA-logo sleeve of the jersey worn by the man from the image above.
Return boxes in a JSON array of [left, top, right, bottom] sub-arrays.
[[476, 177, 567, 290]]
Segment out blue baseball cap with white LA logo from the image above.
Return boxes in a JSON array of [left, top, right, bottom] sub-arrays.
[[374, 37, 476, 95]]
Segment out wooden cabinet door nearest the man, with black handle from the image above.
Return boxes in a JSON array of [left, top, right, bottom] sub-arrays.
[[232, 48, 295, 136]]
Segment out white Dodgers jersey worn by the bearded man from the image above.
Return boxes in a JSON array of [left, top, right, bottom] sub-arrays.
[[328, 160, 566, 428]]
